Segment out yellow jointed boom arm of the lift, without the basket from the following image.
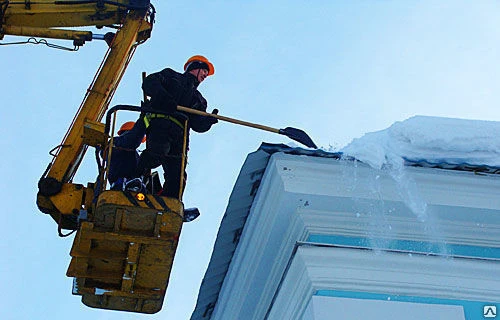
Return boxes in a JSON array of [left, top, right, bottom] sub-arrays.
[[0, 0, 154, 230]]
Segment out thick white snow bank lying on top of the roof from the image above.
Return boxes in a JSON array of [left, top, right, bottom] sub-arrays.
[[341, 116, 500, 169]]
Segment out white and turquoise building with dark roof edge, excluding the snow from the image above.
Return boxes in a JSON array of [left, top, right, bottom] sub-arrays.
[[191, 144, 500, 320]]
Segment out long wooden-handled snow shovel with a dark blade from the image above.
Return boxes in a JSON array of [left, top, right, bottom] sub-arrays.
[[177, 106, 318, 149]]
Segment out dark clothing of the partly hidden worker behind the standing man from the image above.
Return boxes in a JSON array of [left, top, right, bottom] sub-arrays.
[[108, 117, 146, 183]]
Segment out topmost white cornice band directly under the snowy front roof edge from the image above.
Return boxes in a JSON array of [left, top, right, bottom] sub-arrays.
[[273, 153, 500, 209]]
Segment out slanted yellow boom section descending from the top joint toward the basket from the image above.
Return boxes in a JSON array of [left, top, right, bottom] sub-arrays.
[[32, 6, 152, 222]]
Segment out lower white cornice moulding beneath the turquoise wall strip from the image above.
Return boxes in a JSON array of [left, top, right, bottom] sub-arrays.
[[267, 246, 500, 320]]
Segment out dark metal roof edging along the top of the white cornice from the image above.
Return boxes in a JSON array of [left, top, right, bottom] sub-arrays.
[[191, 142, 500, 320]]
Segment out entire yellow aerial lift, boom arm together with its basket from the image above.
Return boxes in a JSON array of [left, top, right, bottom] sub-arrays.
[[0, 0, 187, 313]]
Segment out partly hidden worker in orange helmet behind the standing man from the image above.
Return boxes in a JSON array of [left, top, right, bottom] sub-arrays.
[[108, 117, 146, 191]]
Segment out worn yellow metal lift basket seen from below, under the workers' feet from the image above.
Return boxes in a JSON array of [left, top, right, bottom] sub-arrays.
[[67, 191, 183, 313]]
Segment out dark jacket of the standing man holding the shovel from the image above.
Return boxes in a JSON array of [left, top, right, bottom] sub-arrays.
[[142, 68, 213, 132]]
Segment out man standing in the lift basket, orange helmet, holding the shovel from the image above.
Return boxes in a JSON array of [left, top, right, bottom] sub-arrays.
[[138, 55, 217, 198]]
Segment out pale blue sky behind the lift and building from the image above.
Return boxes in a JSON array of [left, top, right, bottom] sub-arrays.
[[0, 0, 500, 320]]
